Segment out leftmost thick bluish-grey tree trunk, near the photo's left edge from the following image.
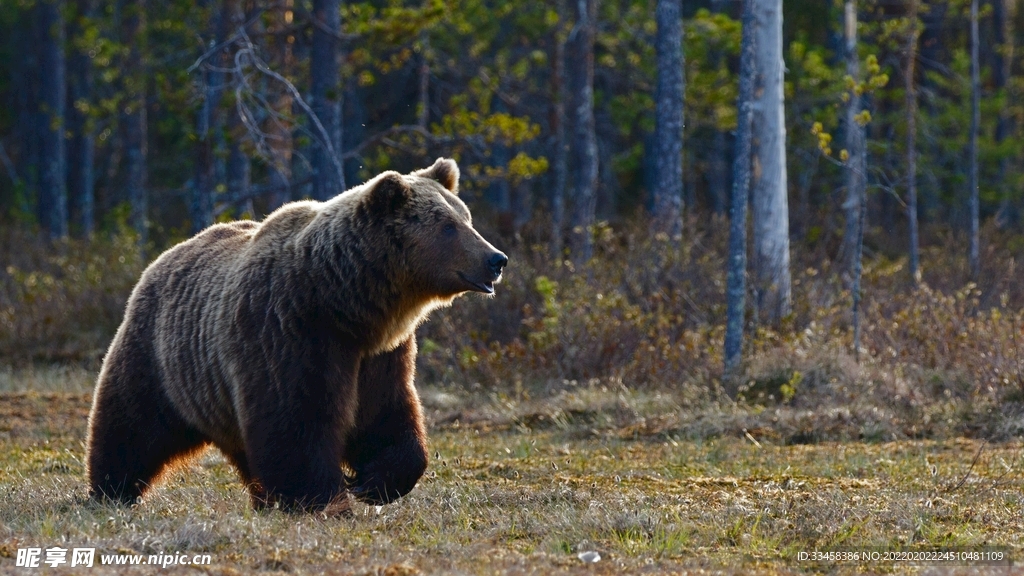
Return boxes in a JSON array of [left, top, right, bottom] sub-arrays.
[[36, 0, 68, 239]]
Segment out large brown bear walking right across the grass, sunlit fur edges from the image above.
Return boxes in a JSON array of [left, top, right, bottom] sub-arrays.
[[87, 159, 508, 511]]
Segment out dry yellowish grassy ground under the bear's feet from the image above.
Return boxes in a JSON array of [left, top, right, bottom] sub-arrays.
[[0, 370, 1024, 575]]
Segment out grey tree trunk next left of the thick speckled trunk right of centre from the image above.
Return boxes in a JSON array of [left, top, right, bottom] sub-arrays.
[[567, 0, 597, 263]]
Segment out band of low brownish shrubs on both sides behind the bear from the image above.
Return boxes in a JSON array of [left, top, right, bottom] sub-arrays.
[[6, 222, 1024, 442]]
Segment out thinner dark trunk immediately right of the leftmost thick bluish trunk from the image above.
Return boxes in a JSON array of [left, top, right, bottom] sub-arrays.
[[68, 0, 96, 238]]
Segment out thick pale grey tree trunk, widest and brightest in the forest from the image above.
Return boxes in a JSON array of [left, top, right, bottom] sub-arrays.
[[752, 0, 791, 322]]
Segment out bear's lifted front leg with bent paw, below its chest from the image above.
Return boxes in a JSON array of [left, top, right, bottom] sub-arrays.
[[345, 336, 427, 504]]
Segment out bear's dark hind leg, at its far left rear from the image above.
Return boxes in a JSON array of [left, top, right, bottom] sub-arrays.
[[87, 354, 207, 504]]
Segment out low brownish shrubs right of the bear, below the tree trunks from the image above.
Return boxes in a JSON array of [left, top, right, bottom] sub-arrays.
[[420, 217, 1024, 440]]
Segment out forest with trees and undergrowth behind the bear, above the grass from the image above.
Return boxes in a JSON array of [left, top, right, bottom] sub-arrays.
[[0, 0, 1024, 434]]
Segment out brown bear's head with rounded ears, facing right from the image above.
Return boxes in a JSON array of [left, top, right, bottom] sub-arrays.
[[367, 158, 508, 299]]
